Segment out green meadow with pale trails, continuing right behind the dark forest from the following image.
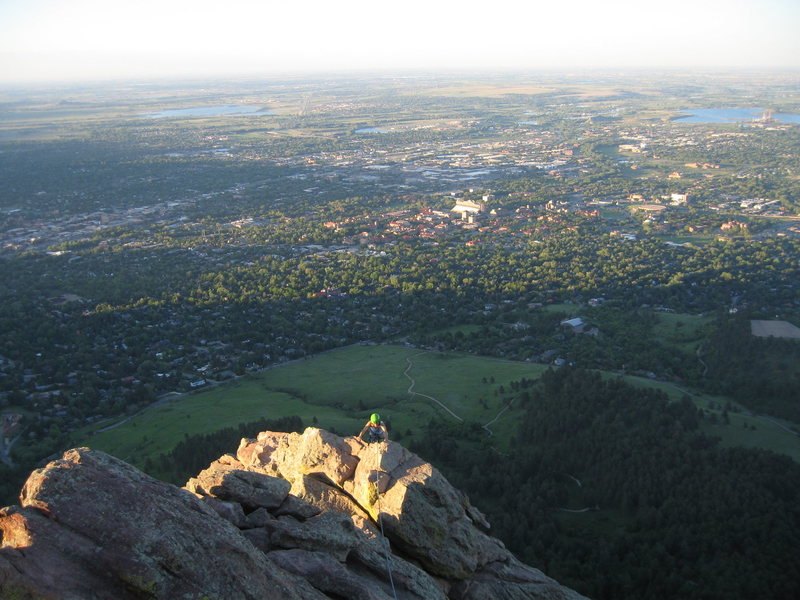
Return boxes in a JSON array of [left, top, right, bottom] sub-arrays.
[[73, 342, 800, 466]]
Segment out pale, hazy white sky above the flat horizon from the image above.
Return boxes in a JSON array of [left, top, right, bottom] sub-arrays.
[[0, 0, 800, 82]]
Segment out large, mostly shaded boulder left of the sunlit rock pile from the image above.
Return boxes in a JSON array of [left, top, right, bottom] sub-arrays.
[[0, 448, 325, 600]]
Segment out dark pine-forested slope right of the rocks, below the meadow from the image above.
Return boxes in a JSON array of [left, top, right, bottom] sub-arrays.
[[415, 370, 800, 600]]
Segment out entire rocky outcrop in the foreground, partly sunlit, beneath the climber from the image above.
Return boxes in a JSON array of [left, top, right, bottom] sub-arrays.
[[0, 428, 580, 600]]
